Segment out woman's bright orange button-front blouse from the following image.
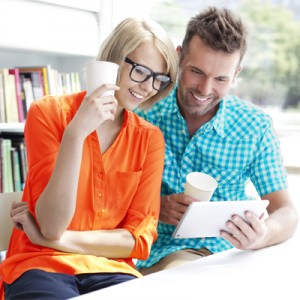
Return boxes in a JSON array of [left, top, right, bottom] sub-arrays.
[[0, 91, 165, 283]]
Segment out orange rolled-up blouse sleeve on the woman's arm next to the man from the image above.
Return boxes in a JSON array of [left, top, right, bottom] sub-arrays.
[[124, 128, 165, 259]]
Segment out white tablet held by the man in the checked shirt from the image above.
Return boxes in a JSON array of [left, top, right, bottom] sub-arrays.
[[173, 200, 269, 238]]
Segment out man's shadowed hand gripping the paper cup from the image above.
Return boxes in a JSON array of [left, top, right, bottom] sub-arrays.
[[159, 193, 197, 226]]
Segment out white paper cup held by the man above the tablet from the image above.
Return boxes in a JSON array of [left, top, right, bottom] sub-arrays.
[[184, 172, 218, 201]]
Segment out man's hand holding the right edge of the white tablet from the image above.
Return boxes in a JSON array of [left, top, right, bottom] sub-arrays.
[[221, 211, 267, 250]]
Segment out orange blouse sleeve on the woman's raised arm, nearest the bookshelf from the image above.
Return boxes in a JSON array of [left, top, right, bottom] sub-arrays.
[[24, 97, 66, 214]]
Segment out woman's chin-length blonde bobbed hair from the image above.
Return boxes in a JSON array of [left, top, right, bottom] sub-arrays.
[[96, 18, 178, 109]]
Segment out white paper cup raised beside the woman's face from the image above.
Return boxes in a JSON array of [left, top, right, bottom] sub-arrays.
[[85, 61, 119, 96]]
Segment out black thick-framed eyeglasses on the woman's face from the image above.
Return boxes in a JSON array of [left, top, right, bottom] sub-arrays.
[[125, 57, 172, 92]]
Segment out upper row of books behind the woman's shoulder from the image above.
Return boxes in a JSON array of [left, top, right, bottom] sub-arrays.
[[0, 65, 81, 123]]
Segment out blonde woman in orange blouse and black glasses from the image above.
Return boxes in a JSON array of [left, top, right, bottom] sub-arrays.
[[0, 18, 177, 299]]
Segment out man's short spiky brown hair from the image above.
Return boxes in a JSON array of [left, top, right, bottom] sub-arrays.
[[181, 7, 248, 62]]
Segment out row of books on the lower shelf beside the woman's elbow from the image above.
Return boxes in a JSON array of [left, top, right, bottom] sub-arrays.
[[0, 136, 28, 193]]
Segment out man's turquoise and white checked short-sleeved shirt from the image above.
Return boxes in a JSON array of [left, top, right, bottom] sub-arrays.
[[136, 88, 287, 268]]
